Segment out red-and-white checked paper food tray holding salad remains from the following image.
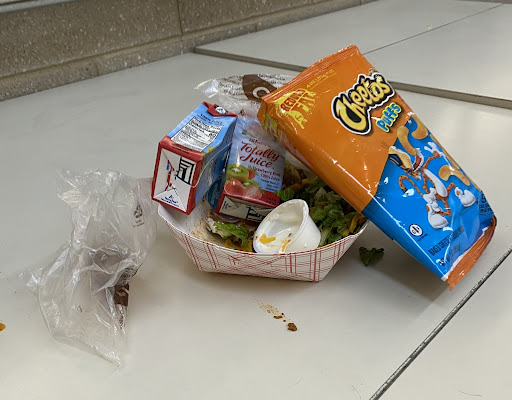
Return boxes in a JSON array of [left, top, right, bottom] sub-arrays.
[[158, 201, 368, 282]]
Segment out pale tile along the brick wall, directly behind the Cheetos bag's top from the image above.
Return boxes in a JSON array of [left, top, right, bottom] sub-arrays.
[[198, 0, 499, 67]]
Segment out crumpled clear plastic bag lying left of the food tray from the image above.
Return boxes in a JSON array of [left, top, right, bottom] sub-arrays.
[[27, 170, 156, 365]]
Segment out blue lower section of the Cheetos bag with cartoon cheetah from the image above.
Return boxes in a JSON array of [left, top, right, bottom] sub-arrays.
[[363, 117, 494, 279]]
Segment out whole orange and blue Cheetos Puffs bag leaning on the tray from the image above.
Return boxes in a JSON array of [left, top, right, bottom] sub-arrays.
[[258, 46, 496, 288]]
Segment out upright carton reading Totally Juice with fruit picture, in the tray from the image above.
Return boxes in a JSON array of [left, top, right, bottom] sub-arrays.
[[206, 121, 284, 222]]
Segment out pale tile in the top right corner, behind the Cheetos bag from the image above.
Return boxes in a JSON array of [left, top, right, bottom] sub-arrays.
[[368, 4, 512, 100]]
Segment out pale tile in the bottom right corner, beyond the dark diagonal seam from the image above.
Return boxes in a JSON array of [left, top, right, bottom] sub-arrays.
[[382, 257, 512, 400]]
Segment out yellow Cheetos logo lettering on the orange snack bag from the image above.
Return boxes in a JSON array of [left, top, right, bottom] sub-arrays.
[[332, 73, 395, 135]]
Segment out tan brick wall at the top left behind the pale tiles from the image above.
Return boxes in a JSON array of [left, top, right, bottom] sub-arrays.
[[0, 0, 367, 100]]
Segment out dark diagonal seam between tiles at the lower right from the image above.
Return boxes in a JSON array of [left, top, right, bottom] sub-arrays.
[[369, 247, 512, 400]]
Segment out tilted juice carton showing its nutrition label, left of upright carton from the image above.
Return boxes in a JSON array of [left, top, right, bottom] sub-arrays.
[[152, 102, 237, 214]]
